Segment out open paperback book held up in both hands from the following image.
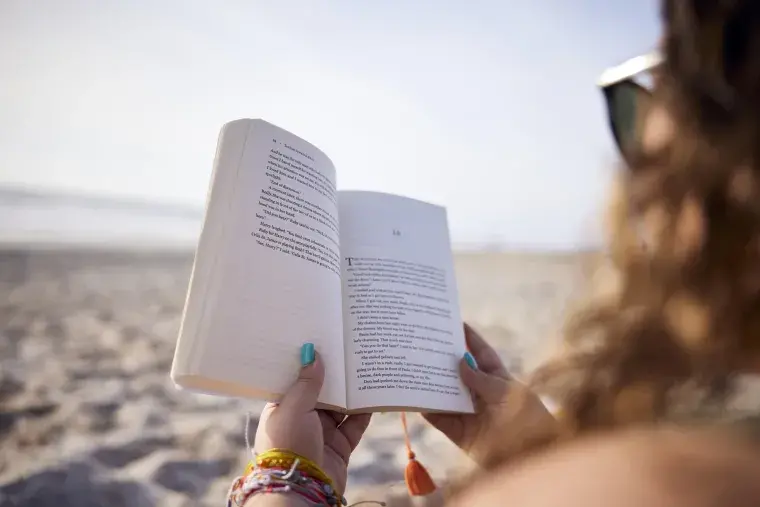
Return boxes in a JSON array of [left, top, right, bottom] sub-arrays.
[[171, 120, 473, 413]]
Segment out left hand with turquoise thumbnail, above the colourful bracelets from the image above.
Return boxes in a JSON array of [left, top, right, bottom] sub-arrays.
[[253, 344, 370, 494]]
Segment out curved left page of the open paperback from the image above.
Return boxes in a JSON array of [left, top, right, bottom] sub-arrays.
[[172, 120, 346, 409]]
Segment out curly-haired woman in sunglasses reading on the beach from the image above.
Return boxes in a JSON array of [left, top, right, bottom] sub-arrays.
[[229, 0, 760, 507]]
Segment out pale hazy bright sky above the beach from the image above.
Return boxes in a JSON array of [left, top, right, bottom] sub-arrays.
[[0, 0, 659, 248]]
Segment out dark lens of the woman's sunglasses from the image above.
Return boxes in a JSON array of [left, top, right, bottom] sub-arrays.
[[604, 81, 650, 155]]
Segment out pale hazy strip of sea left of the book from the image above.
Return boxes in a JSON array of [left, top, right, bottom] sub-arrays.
[[0, 189, 203, 250]]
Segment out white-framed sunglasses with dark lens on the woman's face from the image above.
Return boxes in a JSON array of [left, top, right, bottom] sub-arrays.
[[598, 52, 662, 160]]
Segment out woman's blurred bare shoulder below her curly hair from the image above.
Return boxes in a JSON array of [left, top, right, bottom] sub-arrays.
[[450, 429, 760, 507]]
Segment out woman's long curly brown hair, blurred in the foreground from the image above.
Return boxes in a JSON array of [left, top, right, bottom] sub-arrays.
[[486, 0, 760, 462]]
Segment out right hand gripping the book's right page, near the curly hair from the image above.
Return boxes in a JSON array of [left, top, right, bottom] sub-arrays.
[[423, 324, 555, 465]]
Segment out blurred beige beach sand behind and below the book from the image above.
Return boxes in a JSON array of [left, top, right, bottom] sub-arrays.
[[0, 249, 581, 507]]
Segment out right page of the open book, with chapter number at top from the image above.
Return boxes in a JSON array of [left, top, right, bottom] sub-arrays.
[[338, 191, 473, 412]]
